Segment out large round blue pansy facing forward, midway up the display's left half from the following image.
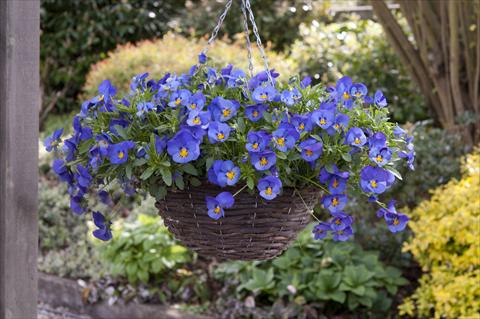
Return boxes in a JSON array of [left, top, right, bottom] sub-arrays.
[[167, 130, 200, 164]]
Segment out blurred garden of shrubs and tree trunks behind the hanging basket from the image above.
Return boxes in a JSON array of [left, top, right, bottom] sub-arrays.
[[38, 0, 480, 318]]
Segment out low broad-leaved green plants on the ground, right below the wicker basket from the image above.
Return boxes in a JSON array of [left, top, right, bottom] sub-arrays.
[[214, 227, 406, 315]]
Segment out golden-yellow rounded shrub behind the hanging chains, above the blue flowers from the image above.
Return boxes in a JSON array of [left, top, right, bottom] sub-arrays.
[[83, 33, 296, 96]]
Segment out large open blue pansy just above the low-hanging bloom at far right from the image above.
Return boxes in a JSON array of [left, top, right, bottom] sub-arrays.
[[360, 166, 395, 194]]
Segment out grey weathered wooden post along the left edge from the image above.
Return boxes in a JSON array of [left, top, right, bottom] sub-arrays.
[[0, 0, 40, 319]]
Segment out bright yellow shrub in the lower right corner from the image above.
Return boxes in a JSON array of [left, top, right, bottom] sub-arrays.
[[400, 148, 480, 318]]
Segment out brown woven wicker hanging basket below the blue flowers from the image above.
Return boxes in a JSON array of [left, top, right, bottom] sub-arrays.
[[156, 184, 320, 260]]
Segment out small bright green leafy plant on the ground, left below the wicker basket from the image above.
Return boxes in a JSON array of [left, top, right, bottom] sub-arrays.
[[99, 214, 193, 283]]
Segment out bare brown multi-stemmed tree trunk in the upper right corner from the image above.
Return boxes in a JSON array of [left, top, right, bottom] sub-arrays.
[[370, 0, 480, 145]]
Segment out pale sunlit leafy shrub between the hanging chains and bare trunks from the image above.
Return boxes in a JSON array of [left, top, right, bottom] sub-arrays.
[[290, 16, 428, 123]]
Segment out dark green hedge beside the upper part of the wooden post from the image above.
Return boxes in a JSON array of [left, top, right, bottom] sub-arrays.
[[40, 0, 185, 115]]
